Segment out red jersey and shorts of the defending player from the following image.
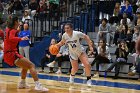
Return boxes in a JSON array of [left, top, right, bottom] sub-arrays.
[[4, 28, 23, 66]]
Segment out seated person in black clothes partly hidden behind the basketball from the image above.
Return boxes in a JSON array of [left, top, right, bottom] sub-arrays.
[[40, 39, 56, 73]]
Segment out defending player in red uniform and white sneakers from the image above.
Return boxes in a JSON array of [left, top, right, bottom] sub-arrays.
[[4, 16, 48, 91]]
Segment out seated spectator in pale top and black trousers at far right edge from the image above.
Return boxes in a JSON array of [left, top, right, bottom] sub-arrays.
[[130, 26, 140, 53]]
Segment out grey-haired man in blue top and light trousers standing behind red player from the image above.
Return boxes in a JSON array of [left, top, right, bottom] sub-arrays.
[[18, 24, 31, 59]]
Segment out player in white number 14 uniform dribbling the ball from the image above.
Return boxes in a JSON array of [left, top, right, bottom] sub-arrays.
[[57, 23, 93, 86]]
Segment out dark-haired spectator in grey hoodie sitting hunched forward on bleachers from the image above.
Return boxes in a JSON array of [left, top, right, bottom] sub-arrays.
[[97, 18, 110, 45]]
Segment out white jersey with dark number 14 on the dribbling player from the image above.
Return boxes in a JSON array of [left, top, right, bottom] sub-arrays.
[[62, 31, 85, 55]]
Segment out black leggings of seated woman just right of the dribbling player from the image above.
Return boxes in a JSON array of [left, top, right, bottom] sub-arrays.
[[91, 55, 110, 71]]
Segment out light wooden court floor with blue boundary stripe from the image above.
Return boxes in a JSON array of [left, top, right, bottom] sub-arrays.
[[0, 68, 140, 93]]
